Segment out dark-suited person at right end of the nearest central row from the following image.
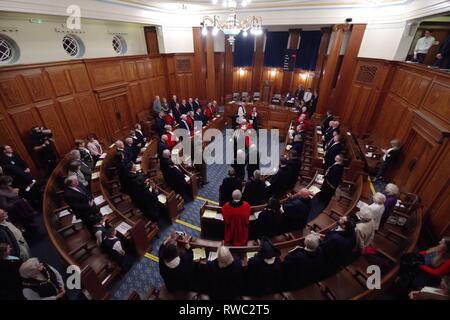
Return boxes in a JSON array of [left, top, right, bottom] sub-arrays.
[[320, 216, 356, 275]]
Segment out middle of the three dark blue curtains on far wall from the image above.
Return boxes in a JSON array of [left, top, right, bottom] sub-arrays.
[[264, 31, 289, 68]]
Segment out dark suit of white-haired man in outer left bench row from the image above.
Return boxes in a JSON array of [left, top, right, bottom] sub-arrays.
[[64, 184, 99, 228]]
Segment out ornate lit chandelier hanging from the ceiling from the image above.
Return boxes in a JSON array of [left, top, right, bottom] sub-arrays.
[[202, 13, 263, 45]]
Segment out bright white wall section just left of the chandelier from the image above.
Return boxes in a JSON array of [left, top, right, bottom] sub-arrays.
[[158, 26, 194, 53]]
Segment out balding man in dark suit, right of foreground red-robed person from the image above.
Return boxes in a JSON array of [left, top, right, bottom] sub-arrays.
[[281, 188, 311, 233]]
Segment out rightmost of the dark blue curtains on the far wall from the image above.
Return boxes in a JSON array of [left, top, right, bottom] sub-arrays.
[[295, 31, 322, 71]]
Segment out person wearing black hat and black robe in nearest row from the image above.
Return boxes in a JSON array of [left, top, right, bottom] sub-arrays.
[[244, 239, 282, 297]]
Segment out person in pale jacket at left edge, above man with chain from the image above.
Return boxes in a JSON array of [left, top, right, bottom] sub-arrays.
[[0, 209, 30, 260]]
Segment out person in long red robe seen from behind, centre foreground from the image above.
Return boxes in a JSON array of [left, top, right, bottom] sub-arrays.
[[222, 190, 251, 246]]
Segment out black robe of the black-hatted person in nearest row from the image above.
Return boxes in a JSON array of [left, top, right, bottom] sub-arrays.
[[244, 255, 282, 296]]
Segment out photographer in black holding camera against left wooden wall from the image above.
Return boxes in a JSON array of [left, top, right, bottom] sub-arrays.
[[31, 127, 57, 176]]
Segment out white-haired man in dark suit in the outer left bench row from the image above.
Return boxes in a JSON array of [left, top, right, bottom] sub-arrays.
[[64, 176, 100, 230]]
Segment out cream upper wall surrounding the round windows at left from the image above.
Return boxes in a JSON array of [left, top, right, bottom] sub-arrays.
[[0, 13, 147, 64]]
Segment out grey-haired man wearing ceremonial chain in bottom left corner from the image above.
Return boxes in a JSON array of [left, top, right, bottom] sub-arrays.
[[19, 258, 66, 300]]
